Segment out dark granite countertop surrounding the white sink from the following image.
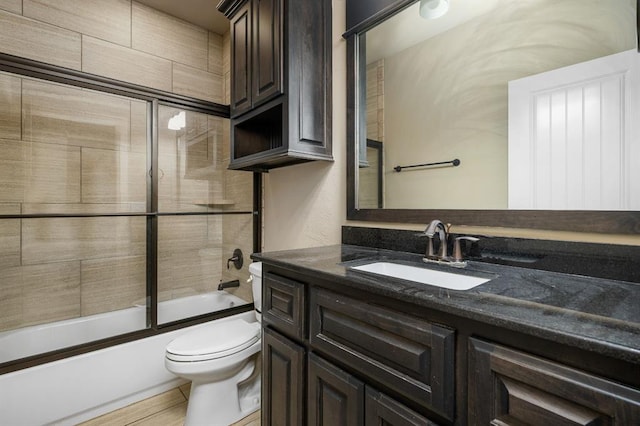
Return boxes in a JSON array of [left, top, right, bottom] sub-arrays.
[[252, 244, 640, 364]]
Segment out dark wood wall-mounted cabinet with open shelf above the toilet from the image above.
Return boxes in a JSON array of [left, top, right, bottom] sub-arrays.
[[218, 0, 333, 171]]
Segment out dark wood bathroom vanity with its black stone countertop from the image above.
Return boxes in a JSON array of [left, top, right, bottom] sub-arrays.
[[254, 244, 640, 425]]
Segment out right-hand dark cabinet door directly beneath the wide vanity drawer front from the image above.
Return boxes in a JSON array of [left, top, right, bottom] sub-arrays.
[[364, 386, 437, 426]]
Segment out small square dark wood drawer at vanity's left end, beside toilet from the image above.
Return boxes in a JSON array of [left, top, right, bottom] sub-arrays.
[[262, 272, 306, 341]]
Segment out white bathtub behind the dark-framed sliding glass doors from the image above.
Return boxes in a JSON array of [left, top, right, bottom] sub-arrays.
[[0, 293, 255, 426]]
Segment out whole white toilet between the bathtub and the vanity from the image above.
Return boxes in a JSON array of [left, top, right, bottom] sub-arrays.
[[165, 262, 262, 426]]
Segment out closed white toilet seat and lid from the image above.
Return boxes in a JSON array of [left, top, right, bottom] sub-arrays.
[[166, 319, 260, 362]]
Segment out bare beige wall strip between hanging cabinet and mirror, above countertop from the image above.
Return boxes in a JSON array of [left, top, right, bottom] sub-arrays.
[[263, 0, 347, 251]]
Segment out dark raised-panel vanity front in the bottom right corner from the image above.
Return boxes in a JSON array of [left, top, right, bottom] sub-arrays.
[[469, 339, 640, 426]]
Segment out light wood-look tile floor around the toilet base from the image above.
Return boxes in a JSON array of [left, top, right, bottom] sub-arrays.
[[81, 383, 260, 426]]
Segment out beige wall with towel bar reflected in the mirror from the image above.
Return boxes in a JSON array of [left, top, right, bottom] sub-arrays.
[[384, 0, 636, 209]]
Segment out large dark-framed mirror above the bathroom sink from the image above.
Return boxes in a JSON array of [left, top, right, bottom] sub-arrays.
[[345, 0, 640, 233]]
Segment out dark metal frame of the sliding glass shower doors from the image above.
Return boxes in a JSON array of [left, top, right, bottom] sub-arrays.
[[0, 53, 262, 375]]
